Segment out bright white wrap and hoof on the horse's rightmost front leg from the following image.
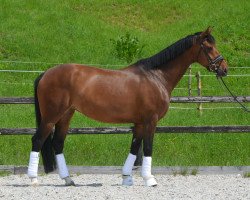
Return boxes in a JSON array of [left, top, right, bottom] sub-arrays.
[[141, 157, 157, 186]]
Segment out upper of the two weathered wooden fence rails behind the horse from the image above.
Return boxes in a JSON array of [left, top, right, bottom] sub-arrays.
[[0, 96, 250, 104]]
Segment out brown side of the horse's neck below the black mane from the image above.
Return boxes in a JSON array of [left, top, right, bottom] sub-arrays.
[[159, 47, 197, 94]]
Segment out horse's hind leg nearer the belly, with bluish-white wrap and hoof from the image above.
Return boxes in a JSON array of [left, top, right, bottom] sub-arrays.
[[52, 110, 75, 186]]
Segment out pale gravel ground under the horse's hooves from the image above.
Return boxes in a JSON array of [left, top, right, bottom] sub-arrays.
[[0, 174, 250, 200]]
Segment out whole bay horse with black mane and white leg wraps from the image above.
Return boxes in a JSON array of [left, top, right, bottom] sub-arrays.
[[28, 27, 228, 186]]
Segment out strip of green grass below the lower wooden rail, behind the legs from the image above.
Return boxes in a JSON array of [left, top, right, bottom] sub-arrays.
[[0, 133, 250, 166]]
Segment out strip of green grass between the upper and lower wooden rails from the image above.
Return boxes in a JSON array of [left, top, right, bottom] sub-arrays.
[[0, 103, 249, 128]]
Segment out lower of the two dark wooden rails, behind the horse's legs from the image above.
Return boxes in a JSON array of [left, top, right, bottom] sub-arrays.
[[0, 126, 250, 135]]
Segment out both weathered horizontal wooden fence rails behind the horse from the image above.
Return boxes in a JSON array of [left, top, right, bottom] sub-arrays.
[[0, 96, 250, 135]]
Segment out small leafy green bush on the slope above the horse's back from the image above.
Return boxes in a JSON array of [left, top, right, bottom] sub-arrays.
[[111, 33, 144, 64]]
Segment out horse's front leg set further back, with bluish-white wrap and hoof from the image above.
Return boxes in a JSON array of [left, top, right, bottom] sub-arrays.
[[122, 124, 143, 186]]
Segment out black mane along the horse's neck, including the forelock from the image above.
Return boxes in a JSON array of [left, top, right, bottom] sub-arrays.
[[135, 32, 215, 69]]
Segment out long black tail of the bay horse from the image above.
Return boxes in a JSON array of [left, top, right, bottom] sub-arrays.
[[34, 74, 56, 173]]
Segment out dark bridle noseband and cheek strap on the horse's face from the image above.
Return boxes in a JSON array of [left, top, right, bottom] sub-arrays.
[[197, 42, 224, 72]]
